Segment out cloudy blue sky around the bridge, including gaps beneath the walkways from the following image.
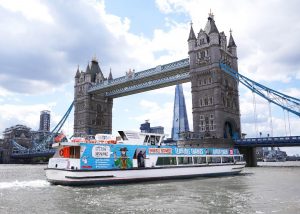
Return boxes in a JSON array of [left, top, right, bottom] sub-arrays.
[[0, 0, 300, 154]]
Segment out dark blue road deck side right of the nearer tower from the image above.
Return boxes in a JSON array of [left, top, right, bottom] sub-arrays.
[[234, 136, 300, 147]]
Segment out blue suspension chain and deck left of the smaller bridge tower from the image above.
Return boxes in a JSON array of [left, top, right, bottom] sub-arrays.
[[11, 101, 74, 158]]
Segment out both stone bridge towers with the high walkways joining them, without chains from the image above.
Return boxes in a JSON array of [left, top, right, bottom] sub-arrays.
[[74, 14, 241, 139]]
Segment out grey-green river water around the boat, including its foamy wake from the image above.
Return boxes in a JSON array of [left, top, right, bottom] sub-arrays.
[[0, 162, 300, 214]]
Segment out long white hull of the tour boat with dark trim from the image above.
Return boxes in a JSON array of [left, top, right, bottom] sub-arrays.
[[45, 164, 245, 186]]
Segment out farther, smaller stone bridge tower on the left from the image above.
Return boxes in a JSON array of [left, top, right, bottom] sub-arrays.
[[74, 58, 113, 136]]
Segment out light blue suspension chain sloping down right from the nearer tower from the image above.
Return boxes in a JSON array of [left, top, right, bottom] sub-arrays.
[[220, 63, 300, 117]]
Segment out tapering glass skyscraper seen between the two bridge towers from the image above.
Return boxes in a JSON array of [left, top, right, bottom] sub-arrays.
[[171, 84, 189, 141]]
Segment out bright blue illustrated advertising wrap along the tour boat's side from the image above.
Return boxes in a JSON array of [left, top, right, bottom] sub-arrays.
[[80, 143, 239, 170]]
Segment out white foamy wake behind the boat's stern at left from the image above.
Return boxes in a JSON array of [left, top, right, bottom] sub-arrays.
[[0, 180, 50, 189]]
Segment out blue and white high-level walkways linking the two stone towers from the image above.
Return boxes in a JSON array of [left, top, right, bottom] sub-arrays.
[[88, 58, 190, 98]]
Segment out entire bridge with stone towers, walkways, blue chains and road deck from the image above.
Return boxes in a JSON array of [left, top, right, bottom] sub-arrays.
[[8, 13, 300, 166]]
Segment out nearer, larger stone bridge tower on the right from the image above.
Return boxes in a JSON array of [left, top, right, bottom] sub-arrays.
[[188, 13, 241, 139]]
